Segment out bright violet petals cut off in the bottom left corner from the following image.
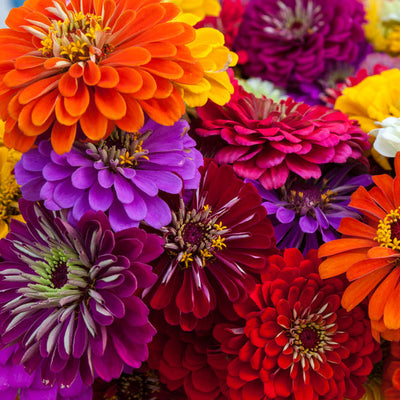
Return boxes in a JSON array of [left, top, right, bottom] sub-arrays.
[[0, 345, 92, 400]]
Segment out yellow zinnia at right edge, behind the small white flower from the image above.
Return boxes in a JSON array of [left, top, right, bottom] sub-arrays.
[[335, 69, 400, 169]]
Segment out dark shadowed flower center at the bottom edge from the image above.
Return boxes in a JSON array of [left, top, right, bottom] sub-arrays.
[[115, 371, 160, 400]]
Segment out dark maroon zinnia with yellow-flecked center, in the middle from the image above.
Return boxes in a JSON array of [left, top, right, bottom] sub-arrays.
[[145, 161, 276, 330]]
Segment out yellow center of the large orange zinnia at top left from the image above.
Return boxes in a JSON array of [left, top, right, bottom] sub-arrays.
[[40, 10, 112, 63]]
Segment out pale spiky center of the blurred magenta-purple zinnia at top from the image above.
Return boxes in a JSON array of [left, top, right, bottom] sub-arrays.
[[262, 0, 324, 40]]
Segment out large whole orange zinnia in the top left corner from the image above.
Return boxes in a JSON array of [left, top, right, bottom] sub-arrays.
[[0, 0, 204, 154]]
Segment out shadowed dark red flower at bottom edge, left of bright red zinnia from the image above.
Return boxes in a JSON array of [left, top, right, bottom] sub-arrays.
[[149, 327, 229, 400]]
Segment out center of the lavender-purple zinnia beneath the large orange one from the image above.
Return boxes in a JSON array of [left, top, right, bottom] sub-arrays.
[[85, 129, 152, 171]]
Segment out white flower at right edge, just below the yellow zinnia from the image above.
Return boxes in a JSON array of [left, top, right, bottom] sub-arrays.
[[369, 117, 400, 157]]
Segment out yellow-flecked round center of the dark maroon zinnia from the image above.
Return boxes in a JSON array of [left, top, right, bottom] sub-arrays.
[[163, 200, 228, 269]]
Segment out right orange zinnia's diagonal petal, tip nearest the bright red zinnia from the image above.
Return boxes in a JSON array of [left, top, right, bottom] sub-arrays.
[[342, 265, 392, 311]]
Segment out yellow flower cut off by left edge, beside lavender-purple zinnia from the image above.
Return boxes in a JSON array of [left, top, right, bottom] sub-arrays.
[[0, 121, 23, 239]]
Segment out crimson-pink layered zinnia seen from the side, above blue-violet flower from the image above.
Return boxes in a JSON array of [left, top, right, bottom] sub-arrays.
[[196, 87, 369, 190]]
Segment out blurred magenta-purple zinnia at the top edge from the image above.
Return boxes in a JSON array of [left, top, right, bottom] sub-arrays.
[[234, 0, 365, 87]]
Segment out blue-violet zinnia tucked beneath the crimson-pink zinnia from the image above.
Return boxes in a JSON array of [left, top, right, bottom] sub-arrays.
[[249, 163, 372, 254]]
